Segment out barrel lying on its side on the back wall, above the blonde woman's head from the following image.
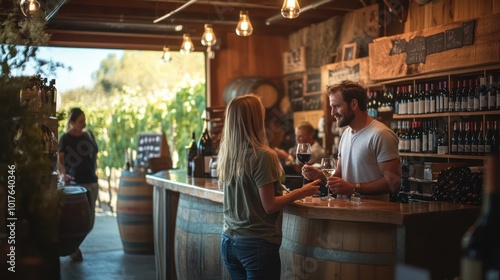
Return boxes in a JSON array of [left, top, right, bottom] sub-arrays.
[[223, 77, 280, 109]]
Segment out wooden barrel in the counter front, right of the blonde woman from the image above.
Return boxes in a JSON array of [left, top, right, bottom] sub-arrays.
[[280, 213, 399, 280]]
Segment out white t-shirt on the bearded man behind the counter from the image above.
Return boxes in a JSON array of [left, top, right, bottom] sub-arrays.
[[339, 120, 399, 201]]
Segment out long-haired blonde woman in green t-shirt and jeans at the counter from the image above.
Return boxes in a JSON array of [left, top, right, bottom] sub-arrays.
[[217, 94, 320, 280]]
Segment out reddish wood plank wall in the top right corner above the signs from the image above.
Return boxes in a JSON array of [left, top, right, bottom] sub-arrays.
[[404, 0, 500, 32]]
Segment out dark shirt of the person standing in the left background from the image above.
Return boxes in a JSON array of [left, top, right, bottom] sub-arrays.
[[59, 132, 98, 184]]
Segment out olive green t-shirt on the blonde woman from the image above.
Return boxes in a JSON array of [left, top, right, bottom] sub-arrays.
[[223, 148, 282, 244]]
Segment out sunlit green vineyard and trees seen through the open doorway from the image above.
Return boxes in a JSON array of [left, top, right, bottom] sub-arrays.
[[57, 51, 206, 176]]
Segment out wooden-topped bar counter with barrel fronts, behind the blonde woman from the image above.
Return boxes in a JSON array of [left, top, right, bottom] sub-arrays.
[[146, 170, 479, 279]]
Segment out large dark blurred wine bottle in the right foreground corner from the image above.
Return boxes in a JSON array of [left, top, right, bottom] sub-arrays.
[[460, 154, 500, 280]]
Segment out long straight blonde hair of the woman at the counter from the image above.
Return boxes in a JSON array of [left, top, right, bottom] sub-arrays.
[[217, 94, 282, 184]]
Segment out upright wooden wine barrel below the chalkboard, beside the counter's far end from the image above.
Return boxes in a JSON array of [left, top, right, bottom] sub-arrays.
[[116, 171, 154, 255]]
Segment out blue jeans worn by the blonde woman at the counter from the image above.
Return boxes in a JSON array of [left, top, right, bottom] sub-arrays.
[[220, 233, 281, 280]]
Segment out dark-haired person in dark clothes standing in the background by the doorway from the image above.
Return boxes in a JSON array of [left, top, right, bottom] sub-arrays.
[[57, 108, 99, 261]]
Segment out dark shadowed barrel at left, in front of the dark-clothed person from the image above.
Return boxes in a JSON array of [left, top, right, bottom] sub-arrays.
[[59, 186, 92, 256]]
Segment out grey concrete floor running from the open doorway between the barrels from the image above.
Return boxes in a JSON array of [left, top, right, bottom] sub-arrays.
[[59, 180, 156, 280]]
